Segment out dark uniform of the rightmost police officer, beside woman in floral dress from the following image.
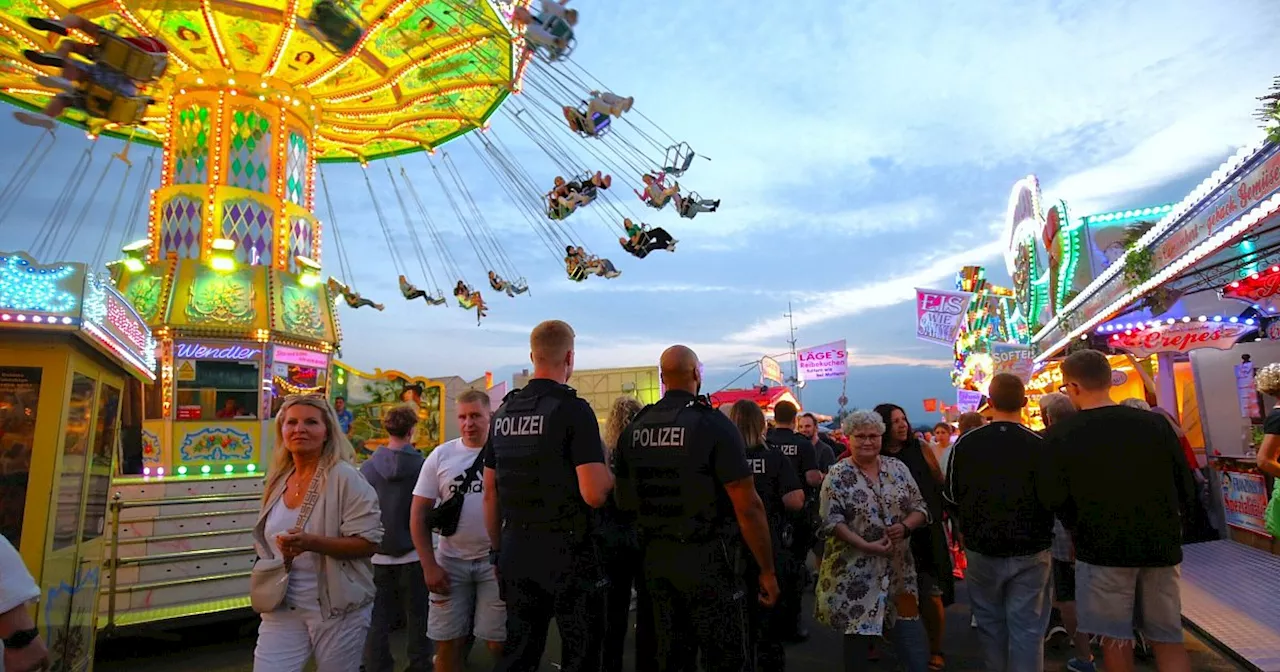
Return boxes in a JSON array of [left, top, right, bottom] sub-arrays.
[[765, 428, 818, 639]]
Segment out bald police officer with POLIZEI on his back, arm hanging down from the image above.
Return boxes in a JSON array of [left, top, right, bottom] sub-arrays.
[[614, 346, 778, 672]]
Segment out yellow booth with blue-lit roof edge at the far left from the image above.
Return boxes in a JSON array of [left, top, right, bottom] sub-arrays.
[[0, 252, 155, 669]]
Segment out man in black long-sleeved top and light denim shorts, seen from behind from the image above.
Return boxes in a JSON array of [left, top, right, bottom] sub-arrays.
[[1046, 351, 1196, 669]]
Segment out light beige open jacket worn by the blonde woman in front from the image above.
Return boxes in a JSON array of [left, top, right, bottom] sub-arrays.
[[253, 462, 383, 620]]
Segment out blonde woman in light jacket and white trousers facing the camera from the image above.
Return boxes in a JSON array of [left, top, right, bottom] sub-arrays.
[[252, 394, 383, 672]]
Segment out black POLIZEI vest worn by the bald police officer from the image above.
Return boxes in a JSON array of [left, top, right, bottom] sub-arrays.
[[626, 398, 732, 543]]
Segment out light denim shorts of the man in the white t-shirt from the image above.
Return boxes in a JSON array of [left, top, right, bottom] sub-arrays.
[[426, 554, 507, 641]]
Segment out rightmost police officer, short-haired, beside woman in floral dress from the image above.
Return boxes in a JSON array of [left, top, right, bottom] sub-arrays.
[[765, 402, 822, 641]]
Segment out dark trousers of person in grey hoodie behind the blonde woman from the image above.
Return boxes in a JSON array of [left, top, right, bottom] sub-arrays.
[[364, 562, 435, 672]]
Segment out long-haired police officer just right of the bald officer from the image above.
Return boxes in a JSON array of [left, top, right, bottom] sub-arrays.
[[728, 399, 804, 672]]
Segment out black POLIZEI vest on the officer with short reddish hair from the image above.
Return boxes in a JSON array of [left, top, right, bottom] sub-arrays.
[[490, 385, 586, 529]]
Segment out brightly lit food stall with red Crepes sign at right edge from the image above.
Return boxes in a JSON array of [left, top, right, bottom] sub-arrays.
[[1013, 141, 1280, 667]]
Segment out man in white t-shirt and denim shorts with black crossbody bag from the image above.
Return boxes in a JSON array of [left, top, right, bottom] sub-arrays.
[[411, 389, 507, 672]]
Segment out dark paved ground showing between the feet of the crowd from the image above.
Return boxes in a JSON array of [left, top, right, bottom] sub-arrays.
[[93, 582, 1245, 672]]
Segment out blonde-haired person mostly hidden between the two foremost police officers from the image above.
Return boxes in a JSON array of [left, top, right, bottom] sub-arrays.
[[600, 397, 654, 672]]
